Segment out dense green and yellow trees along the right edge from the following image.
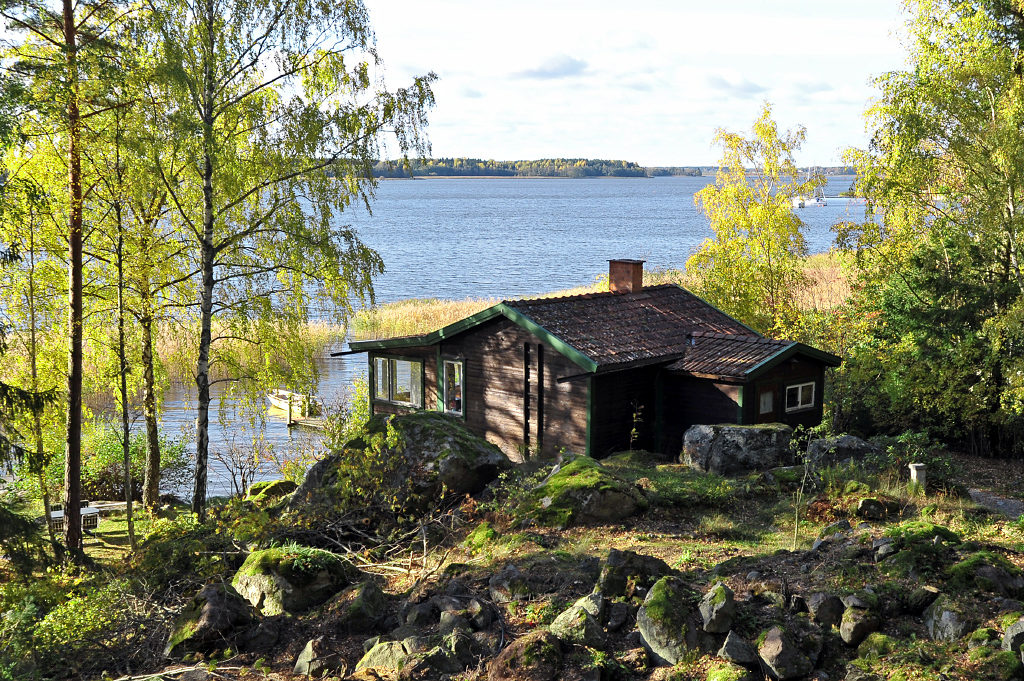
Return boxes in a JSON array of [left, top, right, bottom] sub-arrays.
[[840, 0, 1024, 455]]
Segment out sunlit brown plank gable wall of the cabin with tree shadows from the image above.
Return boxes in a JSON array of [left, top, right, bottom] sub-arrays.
[[440, 318, 587, 457]]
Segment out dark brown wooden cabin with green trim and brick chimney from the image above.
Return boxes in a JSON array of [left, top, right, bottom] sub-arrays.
[[338, 260, 840, 457]]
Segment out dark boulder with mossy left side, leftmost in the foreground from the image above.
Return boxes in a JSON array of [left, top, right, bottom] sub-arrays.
[[164, 584, 255, 657]]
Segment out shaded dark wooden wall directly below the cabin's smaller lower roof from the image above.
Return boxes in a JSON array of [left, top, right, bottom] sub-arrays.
[[658, 372, 742, 458]]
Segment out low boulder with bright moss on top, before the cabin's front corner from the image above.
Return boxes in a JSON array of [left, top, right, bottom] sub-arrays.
[[517, 457, 647, 527]]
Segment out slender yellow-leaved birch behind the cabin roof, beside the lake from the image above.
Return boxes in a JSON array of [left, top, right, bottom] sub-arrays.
[[686, 103, 823, 334]]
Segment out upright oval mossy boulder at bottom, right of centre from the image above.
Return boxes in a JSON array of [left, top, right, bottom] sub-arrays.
[[637, 577, 701, 666]]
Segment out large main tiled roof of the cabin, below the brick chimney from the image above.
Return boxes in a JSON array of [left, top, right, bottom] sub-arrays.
[[504, 284, 754, 371]]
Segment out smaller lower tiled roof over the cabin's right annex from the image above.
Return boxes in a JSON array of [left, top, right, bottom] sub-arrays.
[[668, 331, 796, 378]]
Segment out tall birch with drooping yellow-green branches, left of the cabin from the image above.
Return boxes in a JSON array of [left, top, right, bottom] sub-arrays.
[[151, 0, 434, 517]]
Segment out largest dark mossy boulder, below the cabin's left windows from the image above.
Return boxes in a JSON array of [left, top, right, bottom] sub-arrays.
[[289, 412, 512, 510]]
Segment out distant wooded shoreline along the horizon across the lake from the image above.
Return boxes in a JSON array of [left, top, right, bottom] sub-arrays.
[[374, 158, 855, 177]]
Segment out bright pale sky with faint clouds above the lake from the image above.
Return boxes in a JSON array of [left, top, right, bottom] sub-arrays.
[[366, 0, 905, 166]]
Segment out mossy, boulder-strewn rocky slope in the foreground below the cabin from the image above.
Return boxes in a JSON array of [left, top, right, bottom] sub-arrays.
[[94, 419, 1024, 681]]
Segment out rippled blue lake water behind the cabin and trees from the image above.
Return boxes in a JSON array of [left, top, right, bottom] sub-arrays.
[[163, 176, 864, 495]]
